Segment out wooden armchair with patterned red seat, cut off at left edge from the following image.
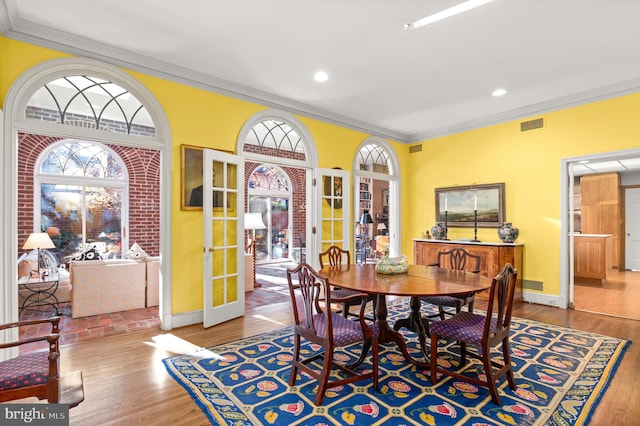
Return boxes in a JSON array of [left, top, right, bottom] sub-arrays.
[[0, 316, 84, 407]]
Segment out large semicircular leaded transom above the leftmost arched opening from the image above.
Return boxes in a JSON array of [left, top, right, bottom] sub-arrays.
[[25, 75, 156, 137]]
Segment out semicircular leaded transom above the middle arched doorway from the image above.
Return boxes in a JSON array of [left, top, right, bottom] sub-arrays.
[[243, 120, 307, 161]]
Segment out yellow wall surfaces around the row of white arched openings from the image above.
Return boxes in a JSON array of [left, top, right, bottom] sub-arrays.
[[0, 36, 406, 314]]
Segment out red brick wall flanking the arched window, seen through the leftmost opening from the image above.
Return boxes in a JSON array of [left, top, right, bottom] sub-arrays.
[[18, 133, 160, 256]]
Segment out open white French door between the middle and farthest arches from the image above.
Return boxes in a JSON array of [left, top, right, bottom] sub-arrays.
[[316, 169, 355, 267]]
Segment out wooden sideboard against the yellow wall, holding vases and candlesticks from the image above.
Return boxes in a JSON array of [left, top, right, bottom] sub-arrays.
[[413, 239, 524, 300]]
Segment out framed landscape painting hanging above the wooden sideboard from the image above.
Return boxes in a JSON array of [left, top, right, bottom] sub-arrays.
[[435, 183, 505, 228]]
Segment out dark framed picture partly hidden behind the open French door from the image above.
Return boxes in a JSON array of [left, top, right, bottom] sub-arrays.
[[180, 145, 231, 210]]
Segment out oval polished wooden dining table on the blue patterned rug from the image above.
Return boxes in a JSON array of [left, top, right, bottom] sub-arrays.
[[319, 264, 492, 369]]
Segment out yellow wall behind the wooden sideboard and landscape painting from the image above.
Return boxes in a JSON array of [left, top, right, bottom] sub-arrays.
[[403, 94, 640, 295]]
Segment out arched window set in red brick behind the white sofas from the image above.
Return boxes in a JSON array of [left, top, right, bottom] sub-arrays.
[[34, 139, 128, 262]]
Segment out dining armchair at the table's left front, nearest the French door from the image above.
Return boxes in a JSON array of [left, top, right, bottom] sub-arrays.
[[287, 263, 379, 405]]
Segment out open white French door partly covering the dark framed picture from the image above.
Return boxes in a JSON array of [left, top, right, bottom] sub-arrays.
[[202, 149, 244, 327]]
